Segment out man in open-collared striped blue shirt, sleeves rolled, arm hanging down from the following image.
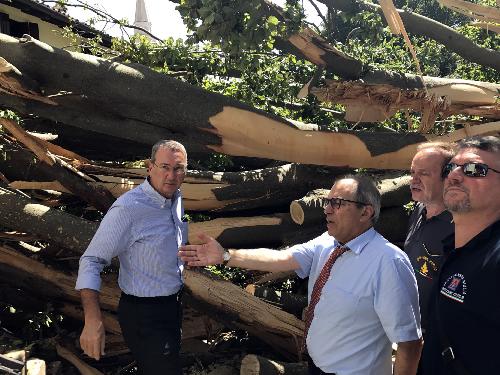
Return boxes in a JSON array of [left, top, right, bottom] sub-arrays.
[[76, 141, 187, 374]]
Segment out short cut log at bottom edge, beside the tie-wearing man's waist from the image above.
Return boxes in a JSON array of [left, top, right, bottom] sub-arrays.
[[240, 354, 309, 375]]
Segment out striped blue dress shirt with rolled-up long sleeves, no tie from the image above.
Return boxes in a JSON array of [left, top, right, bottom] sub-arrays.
[[76, 180, 187, 297]]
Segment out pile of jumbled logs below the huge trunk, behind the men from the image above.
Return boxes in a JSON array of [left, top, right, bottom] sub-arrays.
[[0, 119, 410, 374]]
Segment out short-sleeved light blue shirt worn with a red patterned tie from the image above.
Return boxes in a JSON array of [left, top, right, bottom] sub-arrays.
[[290, 228, 422, 375]]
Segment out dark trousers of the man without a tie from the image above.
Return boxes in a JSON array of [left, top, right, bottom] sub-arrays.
[[118, 293, 182, 375]]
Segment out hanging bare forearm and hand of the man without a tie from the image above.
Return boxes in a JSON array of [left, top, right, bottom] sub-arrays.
[[80, 289, 106, 360]]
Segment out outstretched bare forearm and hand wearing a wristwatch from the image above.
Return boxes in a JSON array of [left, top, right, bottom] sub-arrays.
[[179, 234, 300, 272]]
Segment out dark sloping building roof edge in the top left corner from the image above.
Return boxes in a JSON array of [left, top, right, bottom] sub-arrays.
[[0, 0, 111, 47]]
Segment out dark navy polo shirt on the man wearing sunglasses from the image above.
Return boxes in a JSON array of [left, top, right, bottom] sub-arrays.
[[421, 220, 500, 375]]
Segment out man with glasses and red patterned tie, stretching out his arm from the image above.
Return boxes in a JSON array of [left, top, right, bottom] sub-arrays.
[[179, 176, 422, 375]]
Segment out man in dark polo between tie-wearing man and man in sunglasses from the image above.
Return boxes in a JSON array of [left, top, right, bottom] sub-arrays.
[[404, 142, 454, 338]]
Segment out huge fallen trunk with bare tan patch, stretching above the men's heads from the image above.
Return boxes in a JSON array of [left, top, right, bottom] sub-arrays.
[[0, 35, 496, 169]]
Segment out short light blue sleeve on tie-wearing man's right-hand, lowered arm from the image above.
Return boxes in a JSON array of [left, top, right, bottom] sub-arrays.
[[374, 258, 422, 343]]
